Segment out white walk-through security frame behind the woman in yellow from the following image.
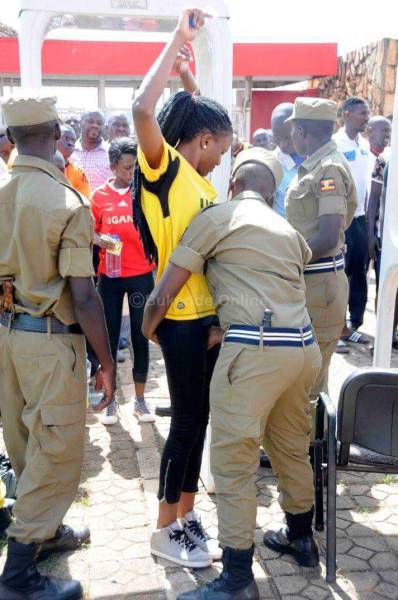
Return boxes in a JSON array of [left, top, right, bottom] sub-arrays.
[[19, 0, 232, 200]]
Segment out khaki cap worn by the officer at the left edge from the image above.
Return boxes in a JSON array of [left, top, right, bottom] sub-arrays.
[[1, 90, 59, 127]]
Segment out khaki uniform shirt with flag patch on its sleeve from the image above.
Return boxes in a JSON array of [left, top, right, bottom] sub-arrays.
[[286, 141, 357, 258]]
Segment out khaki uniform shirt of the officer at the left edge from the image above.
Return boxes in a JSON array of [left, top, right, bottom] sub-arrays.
[[0, 155, 94, 325]]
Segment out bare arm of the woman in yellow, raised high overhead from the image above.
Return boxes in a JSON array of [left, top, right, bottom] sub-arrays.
[[133, 9, 210, 169]]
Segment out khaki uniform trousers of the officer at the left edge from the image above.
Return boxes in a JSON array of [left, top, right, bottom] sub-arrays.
[[0, 326, 87, 544]]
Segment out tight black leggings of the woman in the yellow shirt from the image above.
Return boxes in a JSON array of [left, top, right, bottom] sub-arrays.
[[157, 317, 219, 504]]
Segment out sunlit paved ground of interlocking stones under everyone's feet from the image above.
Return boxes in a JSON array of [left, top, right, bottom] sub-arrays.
[[0, 276, 398, 600]]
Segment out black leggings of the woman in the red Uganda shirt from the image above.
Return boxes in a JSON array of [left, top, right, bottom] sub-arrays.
[[98, 273, 153, 383]]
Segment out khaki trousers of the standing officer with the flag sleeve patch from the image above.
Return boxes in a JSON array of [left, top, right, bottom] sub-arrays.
[[305, 269, 348, 402]]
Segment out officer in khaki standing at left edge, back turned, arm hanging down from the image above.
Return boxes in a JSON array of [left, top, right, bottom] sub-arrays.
[[0, 95, 115, 600]]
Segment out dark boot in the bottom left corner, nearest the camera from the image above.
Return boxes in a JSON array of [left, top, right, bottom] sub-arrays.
[[0, 538, 83, 600]]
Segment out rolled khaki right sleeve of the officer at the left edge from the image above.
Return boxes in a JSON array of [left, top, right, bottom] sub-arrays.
[[58, 205, 95, 277]]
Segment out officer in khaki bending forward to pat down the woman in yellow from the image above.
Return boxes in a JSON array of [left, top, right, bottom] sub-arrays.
[[143, 148, 320, 600]]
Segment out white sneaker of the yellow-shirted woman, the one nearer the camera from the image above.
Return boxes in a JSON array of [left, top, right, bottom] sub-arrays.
[[151, 521, 212, 569]]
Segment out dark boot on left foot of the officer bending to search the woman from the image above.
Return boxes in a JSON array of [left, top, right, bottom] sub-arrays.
[[177, 545, 260, 600]]
